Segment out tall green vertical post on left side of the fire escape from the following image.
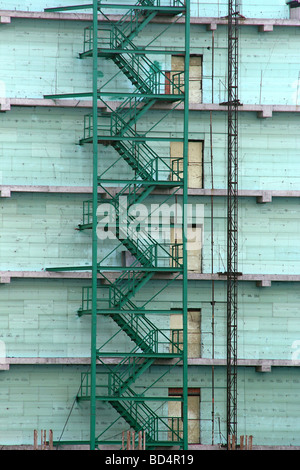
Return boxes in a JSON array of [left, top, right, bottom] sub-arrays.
[[90, 0, 98, 450]]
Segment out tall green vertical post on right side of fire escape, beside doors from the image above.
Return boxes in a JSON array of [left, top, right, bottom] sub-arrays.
[[183, 0, 190, 450]]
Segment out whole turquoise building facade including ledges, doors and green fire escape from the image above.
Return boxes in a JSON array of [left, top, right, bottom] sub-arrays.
[[0, 0, 300, 449]]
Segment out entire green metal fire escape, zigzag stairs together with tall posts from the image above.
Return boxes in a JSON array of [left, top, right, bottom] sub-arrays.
[[44, 0, 189, 449]]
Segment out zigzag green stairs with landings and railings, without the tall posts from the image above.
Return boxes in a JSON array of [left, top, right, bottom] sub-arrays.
[[42, 0, 185, 448]]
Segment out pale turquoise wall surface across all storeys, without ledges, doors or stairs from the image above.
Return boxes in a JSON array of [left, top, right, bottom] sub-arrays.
[[0, 0, 300, 446]]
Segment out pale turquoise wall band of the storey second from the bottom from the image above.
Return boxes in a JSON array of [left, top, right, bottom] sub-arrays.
[[0, 280, 300, 360]]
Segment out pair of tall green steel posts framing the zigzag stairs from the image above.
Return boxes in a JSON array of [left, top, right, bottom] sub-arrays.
[[46, 0, 190, 450]]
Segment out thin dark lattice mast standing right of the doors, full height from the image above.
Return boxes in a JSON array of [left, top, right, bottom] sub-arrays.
[[227, 0, 239, 448]]
